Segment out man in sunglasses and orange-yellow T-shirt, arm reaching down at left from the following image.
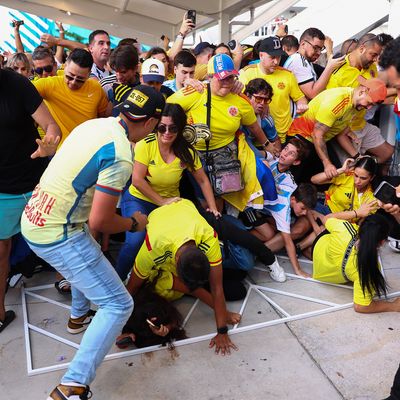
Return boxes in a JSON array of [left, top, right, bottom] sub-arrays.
[[34, 49, 111, 147]]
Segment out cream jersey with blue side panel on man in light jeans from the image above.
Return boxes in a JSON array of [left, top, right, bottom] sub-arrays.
[[21, 117, 133, 246]]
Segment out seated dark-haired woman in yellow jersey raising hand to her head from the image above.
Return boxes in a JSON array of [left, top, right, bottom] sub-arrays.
[[311, 156, 378, 222]]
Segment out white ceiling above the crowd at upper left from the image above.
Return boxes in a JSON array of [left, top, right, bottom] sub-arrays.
[[0, 0, 276, 45]]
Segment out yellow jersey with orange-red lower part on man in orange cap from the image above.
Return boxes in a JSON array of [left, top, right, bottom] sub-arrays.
[[288, 88, 356, 142]]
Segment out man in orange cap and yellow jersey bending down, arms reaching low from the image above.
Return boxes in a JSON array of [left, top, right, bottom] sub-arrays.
[[288, 78, 387, 182]]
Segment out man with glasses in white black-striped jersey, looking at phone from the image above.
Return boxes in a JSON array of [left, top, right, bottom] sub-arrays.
[[283, 28, 344, 100]]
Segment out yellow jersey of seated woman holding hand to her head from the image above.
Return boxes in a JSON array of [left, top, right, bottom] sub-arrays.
[[325, 171, 376, 213]]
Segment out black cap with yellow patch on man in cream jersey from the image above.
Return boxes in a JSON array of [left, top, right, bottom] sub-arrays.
[[115, 85, 165, 121]]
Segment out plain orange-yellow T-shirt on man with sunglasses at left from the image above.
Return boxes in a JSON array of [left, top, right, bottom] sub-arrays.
[[33, 76, 108, 147]]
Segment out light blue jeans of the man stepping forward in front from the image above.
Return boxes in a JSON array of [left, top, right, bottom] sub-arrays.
[[29, 232, 133, 385]]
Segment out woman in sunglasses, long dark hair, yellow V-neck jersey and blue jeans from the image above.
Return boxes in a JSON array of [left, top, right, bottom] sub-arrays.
[[116, 104, 220, 280]]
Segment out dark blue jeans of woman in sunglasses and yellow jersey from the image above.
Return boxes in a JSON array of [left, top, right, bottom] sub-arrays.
[[115, 190, 157, 281]]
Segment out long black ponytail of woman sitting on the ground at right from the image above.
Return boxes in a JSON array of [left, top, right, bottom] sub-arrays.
[[357, 214, 389, 296]]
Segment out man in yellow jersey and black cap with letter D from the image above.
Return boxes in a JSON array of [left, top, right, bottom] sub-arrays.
[[239, 36, 307, 143]]
